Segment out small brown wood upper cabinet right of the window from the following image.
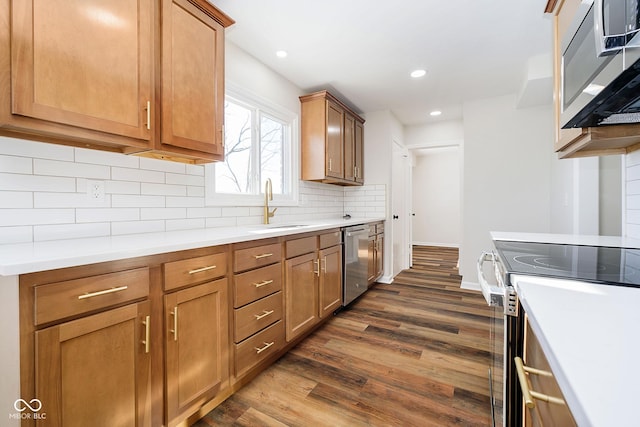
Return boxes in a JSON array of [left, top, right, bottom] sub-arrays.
[[300, 91, 364, 185]]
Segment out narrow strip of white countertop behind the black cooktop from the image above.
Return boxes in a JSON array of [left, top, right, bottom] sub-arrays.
[[491, 231, 640, 248]]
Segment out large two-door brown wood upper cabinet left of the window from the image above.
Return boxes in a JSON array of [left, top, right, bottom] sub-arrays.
[[0, 0, 233, 163]]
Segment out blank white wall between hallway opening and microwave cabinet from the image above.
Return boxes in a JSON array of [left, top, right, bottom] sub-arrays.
[[460, 95, 553, 283]]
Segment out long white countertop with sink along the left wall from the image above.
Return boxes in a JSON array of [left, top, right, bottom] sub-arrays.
[[0, 218, 384, 276]]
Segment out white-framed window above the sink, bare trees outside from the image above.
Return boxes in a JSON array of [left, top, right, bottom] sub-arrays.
[[206, 89, 298, 206]]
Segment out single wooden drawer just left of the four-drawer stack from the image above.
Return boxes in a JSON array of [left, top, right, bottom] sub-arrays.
[[164, 252, 227, 290]]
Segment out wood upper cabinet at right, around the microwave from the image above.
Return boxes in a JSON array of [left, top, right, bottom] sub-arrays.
[[545, 0, 640, 158]]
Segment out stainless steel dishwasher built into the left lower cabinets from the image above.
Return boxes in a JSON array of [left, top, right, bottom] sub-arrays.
[[342, 224, 369, 306]]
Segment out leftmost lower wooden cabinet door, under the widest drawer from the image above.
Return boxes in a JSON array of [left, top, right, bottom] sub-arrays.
[[35, 302, 151, 427]]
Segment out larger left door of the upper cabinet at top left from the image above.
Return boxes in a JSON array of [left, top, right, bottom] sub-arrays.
[[11, 0, 154, 141]]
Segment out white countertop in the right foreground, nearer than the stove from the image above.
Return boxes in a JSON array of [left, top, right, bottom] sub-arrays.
[[512, 276, 640, 427]]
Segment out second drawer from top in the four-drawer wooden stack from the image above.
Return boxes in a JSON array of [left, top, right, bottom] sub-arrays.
[[233, 263, 282, 308]]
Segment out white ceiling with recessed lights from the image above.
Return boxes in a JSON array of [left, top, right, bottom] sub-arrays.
[[210, 0, 551, 125]]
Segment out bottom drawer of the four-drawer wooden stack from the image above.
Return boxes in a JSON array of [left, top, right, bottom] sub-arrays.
[[235, 320, 285, 377]]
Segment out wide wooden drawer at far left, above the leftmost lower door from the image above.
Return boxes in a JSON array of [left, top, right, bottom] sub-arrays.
[[35, 267, 149, 325]]
